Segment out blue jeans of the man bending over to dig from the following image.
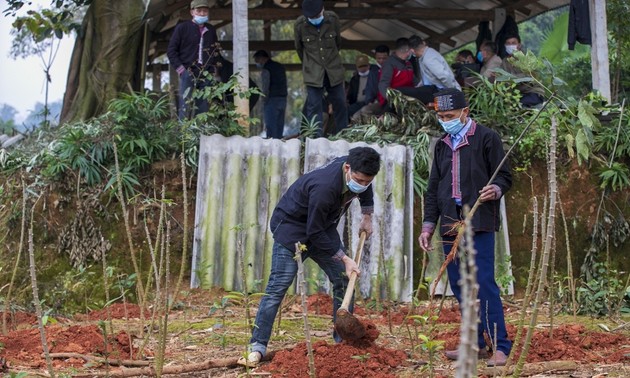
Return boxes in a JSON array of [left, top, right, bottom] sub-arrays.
[[250, 242, 354, 356]]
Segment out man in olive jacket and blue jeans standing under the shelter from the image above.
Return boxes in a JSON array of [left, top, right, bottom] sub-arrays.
[[294, 0, 348, 136]]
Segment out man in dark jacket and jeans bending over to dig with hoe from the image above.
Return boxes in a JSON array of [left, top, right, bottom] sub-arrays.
[[238, 147, 380, 367]]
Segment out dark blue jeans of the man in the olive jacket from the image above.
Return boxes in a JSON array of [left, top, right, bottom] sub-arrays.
[[305, 75, 348, 137]]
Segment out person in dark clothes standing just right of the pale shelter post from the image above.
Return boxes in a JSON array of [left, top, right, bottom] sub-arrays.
[[254, 50, 287, 139]]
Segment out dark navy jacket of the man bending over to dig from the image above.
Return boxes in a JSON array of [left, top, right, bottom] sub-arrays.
[[270, 156, 374, 256]]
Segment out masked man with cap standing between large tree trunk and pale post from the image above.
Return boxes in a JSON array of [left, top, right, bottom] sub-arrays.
[[166, 0, 220, 120]]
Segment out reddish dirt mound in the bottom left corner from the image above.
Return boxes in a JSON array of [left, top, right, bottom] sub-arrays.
[[0, 325, 135, 368]]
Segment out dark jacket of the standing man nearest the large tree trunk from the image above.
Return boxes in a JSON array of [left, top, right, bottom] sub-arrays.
[[166, 20, 220, 73]]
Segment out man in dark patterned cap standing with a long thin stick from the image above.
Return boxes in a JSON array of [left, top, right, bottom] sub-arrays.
[[418, 89, 512, 366]]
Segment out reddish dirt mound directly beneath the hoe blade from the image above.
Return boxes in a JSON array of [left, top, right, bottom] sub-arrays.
[[261, 321, 407, 378]]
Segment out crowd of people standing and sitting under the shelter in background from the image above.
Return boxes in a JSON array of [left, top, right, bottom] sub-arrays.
[[168, 0, 544, 138]]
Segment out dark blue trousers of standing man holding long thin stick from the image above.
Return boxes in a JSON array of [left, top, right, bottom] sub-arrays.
[[442, 232, 512, 355]]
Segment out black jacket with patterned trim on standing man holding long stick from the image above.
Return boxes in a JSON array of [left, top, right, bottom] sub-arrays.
[[423, 121, 512, 235]]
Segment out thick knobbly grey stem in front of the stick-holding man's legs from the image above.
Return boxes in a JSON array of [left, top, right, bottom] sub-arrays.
[[455, 209, 478, 378]]
